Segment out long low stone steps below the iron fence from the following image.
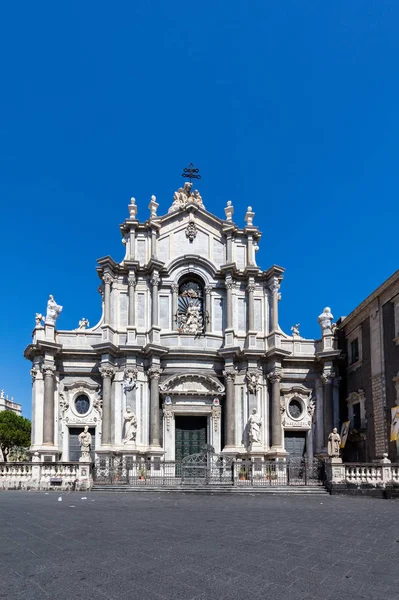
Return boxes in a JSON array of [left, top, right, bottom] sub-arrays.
[[92, 484, 328, 496]]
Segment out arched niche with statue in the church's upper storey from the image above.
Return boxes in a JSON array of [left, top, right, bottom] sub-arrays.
[[177, 279, 204, 335]]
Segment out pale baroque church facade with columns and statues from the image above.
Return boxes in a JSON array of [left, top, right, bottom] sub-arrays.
[[25, 183, 340, 461]]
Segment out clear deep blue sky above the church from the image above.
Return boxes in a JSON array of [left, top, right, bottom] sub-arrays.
[[0, 0, 399, 416]]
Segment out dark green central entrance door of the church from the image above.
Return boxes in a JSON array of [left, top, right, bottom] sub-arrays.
[[175, 415, 207, 461]]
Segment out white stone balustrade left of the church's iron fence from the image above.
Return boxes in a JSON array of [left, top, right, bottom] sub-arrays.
[[0, 462, 87, 490]]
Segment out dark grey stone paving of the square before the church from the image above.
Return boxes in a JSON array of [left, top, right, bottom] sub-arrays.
[[0, 492, 399, 600]]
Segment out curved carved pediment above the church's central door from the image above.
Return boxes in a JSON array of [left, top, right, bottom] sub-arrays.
[[160, 373, 224, 396]]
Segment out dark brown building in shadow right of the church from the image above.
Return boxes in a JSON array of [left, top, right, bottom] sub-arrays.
[[338, 271, 399, 462]]
